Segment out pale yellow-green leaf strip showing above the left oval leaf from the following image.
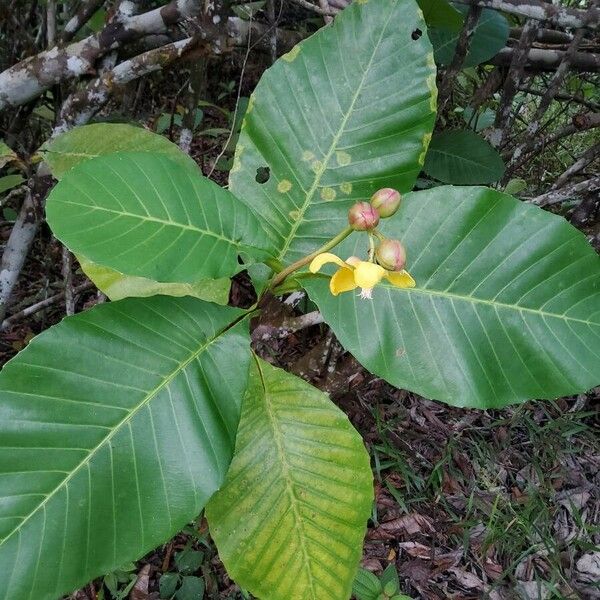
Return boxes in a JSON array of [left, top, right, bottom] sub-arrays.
[[41, 123, 200, 179]]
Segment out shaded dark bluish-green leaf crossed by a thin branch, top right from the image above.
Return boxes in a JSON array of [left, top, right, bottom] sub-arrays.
[[429, 5, 510, 67]]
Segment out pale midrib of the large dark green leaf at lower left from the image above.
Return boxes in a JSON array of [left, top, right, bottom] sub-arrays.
[[0, 313, 247, 548]]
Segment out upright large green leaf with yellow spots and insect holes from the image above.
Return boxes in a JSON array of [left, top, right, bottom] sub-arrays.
[[230, 0, 437, 262]]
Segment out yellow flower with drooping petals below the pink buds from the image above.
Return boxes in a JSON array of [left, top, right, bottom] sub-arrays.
[[309, 252, 415, 299]]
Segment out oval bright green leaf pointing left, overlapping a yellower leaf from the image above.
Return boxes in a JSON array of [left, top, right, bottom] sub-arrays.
[[46, 152, 272, 283]]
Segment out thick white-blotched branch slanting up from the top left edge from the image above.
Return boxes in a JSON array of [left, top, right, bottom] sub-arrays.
[[0, 0, 199, 110]]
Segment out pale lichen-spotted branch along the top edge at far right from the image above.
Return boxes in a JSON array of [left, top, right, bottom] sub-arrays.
[[457, 0, 600, 29]]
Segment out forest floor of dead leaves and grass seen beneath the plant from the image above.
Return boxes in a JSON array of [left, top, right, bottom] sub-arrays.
[[0, 75, 600, 600]]
